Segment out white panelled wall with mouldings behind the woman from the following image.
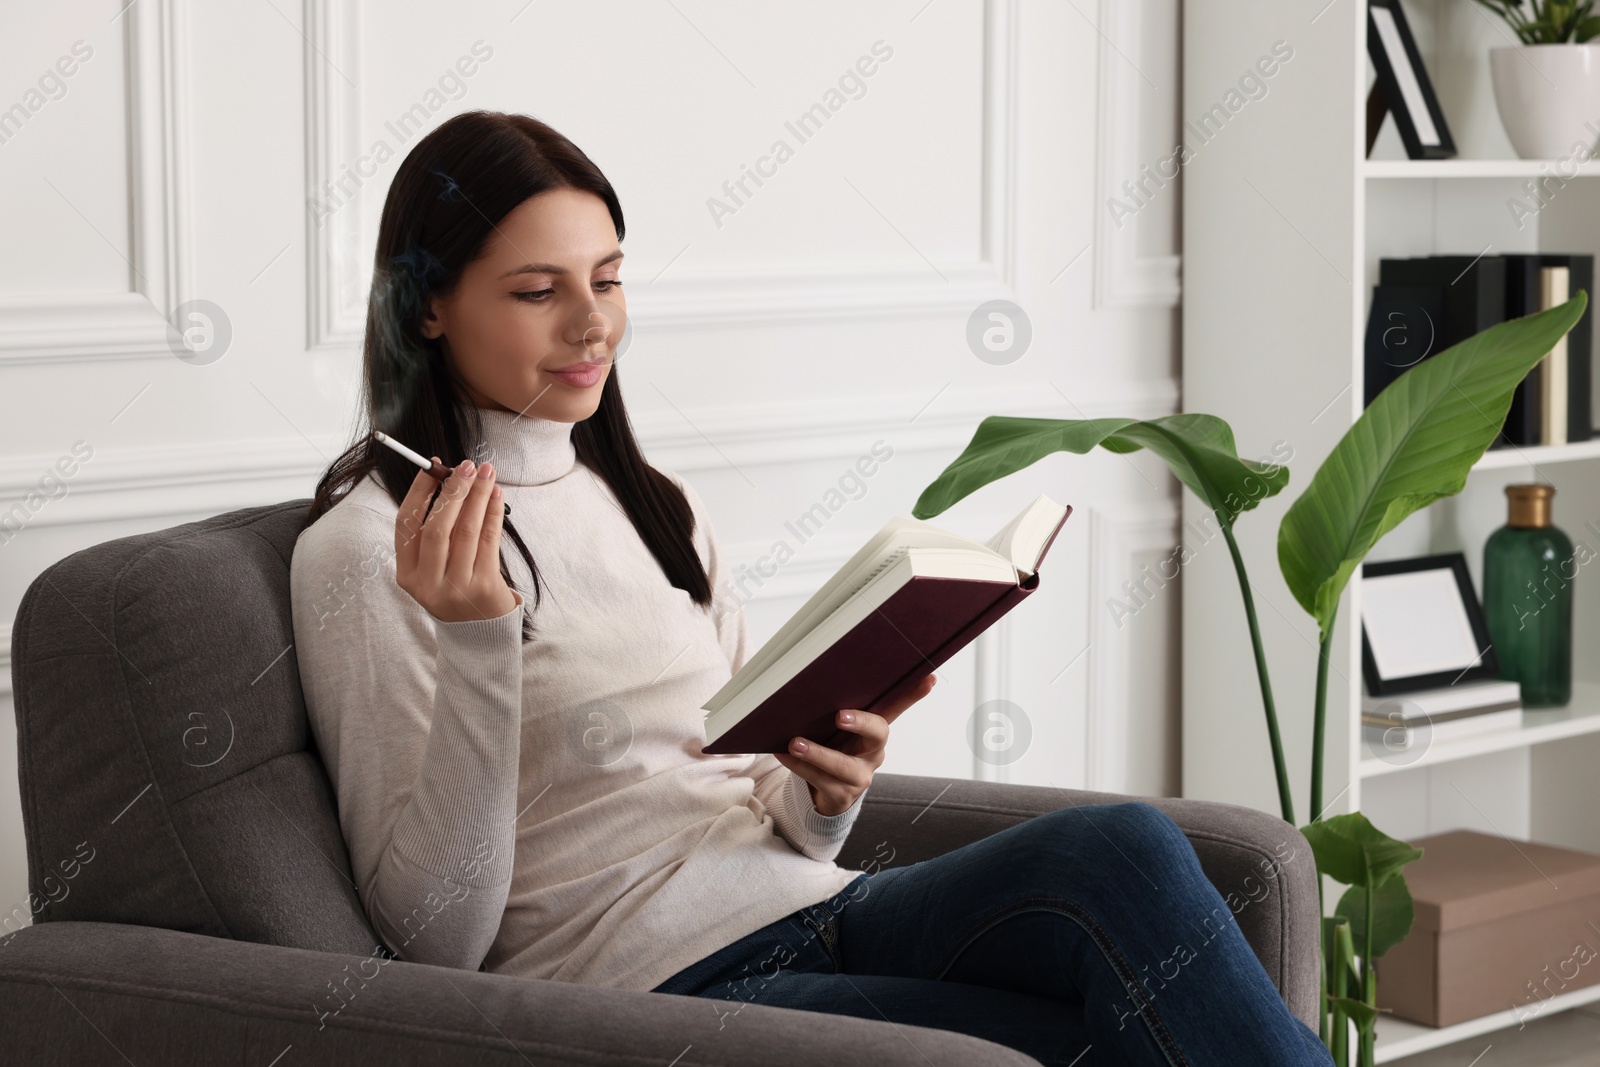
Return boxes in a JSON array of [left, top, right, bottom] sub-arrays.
[[0, 0, 1179, 910]]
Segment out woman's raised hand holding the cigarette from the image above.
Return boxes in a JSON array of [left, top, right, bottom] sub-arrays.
[[395, 456, 522, 622]]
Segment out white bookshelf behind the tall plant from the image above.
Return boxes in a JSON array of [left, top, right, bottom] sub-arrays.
[[1182, 0, 1600, 1067]]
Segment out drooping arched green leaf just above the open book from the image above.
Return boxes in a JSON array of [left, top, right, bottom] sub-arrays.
[[910, 414, 1290, 526]]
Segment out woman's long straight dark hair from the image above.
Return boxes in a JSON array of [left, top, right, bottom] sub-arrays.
[[306, 110, 710, 641]]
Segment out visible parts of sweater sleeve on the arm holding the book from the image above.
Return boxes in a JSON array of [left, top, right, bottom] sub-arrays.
[[674, 477, 870, 862]]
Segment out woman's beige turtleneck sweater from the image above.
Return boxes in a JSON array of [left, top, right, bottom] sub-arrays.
[[290, 410, 861, 990]]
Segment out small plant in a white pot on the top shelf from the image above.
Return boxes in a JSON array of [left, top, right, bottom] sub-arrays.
[[1477, 0, 1600, 160]]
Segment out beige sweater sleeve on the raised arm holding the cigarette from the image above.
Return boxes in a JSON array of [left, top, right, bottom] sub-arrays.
[[290, 502, 522, 969]]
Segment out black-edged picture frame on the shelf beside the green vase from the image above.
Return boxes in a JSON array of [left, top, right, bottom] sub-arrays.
[[1362, 552, 1499, 696]]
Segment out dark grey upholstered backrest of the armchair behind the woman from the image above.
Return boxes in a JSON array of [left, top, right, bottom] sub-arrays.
[[11, 501, 378, 952]]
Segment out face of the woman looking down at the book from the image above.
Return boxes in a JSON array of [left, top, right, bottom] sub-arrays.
[[422, 189, 627, 422]]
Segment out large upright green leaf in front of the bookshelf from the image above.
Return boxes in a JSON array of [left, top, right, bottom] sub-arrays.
[[1278, 290, 1589, 638]]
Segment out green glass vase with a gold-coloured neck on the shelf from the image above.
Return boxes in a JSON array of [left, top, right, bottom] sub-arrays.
[[1483, 485, 1578, 707]]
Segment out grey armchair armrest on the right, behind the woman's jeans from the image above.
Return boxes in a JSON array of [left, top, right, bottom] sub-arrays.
[[835, 771, 1322, 1030]]
